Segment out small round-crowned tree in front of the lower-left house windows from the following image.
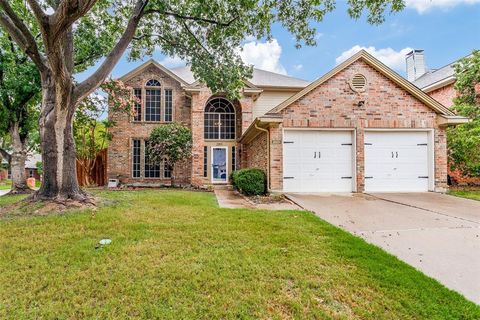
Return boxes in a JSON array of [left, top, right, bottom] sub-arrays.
[[146, 123, 192, 186]]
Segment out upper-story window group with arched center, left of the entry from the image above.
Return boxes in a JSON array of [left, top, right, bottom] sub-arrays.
[[133, 79, 173, 122]]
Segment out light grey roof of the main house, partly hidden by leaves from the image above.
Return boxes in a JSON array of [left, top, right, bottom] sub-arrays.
[[170, 66, 310, 88]]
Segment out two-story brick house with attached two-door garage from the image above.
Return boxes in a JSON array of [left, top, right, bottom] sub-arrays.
[[107, 51, 467, 192]]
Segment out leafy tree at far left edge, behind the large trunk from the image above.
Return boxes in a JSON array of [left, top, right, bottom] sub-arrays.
[[0, 30, 41, 194]]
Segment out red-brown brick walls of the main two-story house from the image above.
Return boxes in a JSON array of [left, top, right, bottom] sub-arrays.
[[108, 59, 454, 192]]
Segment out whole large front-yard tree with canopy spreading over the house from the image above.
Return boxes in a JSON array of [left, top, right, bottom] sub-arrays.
[[0, 0, 405, 201]]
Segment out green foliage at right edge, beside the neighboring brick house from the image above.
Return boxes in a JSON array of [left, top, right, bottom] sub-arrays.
[[447, 50, 480, 176]]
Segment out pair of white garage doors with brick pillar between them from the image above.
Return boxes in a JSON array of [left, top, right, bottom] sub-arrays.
[[283, 129, 433, 193]]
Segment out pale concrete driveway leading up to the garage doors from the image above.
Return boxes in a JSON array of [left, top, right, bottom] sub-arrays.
[[288, 193, 480, 304]]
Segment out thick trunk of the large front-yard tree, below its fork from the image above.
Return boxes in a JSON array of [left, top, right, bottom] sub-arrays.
[[33, 74, 89, 201]]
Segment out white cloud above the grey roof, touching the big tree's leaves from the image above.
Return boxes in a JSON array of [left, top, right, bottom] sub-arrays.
[[239, 39, 287, 74]]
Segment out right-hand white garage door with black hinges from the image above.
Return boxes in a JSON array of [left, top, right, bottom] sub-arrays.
[[365, 131, 429, 192]]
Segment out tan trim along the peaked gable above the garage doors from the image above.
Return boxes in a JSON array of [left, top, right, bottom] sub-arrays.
[[267, 50, 454, 115]]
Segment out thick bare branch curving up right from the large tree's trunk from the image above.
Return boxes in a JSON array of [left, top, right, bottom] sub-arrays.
[[74, 0, 148, 101]]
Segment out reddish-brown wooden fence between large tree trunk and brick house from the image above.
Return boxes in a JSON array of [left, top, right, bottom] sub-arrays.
[[76, 149, 107, 187]]
